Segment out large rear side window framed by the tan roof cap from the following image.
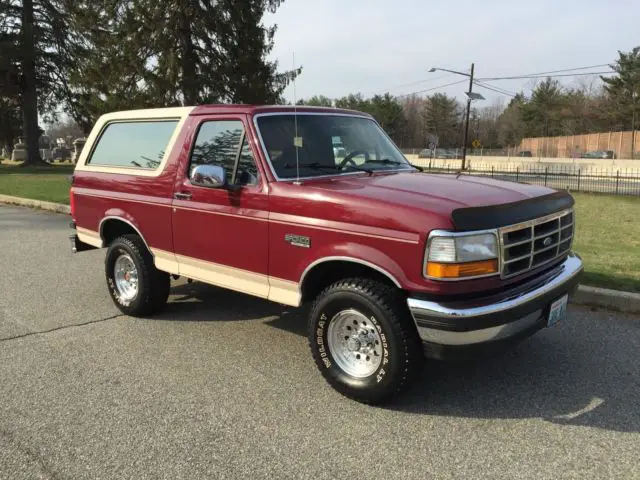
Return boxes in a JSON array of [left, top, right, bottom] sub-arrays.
[[87, 120, 178, 170]]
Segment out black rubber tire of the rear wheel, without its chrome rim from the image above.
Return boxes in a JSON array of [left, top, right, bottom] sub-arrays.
[[104, 234, 171, 317]]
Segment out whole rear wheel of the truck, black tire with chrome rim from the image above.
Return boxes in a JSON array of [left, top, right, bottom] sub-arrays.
[[105, 235, 170, 317]]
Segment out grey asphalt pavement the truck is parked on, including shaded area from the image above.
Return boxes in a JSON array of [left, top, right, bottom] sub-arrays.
[[0, 207, 640, 480]]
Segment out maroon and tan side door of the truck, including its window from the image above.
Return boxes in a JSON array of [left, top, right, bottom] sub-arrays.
[[172, 115, 269, 297]]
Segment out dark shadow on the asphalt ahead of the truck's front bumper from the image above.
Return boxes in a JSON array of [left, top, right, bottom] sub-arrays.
[[389, 307, 640, 432]]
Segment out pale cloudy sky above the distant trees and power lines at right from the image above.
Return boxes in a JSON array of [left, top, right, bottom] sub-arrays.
[[264, 0, 640, 103]]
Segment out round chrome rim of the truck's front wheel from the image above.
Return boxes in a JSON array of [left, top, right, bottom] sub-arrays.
[[327, 309, 382, 378]]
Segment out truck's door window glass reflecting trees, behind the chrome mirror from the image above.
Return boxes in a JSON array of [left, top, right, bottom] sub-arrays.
[[189, 120, 258, 185]]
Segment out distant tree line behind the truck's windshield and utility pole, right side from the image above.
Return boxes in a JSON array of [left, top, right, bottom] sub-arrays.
[[298, 47, 640, 153]]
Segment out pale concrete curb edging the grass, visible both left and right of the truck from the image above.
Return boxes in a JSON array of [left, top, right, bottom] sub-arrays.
[[0, 195, 640, 313]]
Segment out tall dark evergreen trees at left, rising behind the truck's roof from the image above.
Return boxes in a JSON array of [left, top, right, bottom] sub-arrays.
[[0, 0, 301, 164]]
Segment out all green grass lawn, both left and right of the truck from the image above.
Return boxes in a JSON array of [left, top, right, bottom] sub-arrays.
[[0, 164, 640, 292]]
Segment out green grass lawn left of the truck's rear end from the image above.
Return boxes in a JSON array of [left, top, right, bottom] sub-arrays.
[[0, 162, 74, 203]]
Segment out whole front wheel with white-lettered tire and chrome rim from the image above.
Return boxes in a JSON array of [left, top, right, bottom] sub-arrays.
[[309, 278, 423, 404]]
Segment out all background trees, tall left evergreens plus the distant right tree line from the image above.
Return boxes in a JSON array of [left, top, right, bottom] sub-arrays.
[[0, 0, 640, 164]]
